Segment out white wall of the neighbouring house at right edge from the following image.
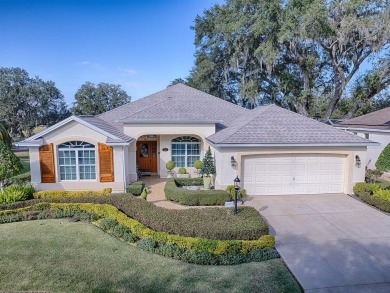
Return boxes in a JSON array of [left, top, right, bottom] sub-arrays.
[[351, 130, 390, 169]]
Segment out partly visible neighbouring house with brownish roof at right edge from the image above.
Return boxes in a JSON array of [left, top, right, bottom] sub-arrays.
[[334, 107, 390, 169]]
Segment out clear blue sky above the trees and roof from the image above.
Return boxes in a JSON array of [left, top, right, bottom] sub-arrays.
[[0, 0, 223, 104]]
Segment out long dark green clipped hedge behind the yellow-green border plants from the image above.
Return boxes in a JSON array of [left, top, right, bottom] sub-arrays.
[[0, 194, 269, 240]]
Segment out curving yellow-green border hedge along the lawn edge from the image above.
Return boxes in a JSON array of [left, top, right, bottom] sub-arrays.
[[0, 203, 277, 264]]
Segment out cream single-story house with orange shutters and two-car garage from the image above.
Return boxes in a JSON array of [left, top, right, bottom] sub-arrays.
[[19, 84, 373, 195]]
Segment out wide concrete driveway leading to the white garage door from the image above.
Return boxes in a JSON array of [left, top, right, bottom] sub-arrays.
[[246, 194, 390, 293]]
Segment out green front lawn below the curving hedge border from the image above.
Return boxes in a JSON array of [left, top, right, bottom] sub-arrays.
[[0, 219, 300, 293]]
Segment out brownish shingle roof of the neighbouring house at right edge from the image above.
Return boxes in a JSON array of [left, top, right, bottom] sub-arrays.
[[334, 107, 390, 130]]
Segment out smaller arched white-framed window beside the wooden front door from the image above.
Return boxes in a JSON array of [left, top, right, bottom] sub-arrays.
[[172, 136, 200, 167]]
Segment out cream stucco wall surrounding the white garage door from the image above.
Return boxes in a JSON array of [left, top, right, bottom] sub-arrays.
[[213, 147, 366, 193]]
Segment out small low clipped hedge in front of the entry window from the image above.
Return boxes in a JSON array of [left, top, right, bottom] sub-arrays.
[[164, 179, 230, 206]]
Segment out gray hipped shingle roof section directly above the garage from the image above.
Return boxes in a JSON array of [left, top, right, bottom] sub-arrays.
[[207, 105, 371, 145]]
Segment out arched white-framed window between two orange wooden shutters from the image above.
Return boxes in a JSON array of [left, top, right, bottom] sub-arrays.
[[58, 141, 96, 181]]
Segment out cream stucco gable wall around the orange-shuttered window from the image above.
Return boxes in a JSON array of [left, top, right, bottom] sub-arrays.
[[29, 121, 127, 193]]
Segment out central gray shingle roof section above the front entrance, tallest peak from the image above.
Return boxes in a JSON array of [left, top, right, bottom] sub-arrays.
[[97, 84, 250, 127]]
